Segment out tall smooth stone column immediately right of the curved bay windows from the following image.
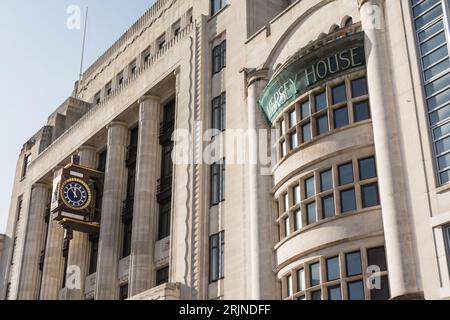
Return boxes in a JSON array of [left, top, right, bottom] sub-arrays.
[[358, 0, 423, 299]]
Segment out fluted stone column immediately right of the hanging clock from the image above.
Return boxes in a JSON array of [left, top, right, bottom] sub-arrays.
[[96, 121, 128, 300]]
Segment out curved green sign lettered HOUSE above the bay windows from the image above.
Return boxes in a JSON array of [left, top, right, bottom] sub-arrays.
[[259, 33, 366, 124]]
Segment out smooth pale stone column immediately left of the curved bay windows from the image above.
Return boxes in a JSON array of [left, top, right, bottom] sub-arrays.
[[247, 70, 276, 300]]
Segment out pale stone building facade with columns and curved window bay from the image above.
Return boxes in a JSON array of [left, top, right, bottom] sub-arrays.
[[0, 0, 450, 300]]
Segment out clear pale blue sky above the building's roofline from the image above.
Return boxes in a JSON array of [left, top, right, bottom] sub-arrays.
[[0, 0, 154, 233]]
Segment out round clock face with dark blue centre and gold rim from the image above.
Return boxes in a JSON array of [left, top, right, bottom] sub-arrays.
[[61, 179, 91, 210]]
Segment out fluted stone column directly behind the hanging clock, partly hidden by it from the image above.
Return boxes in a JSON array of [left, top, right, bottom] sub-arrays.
[[65, 146, 98, 300]]
